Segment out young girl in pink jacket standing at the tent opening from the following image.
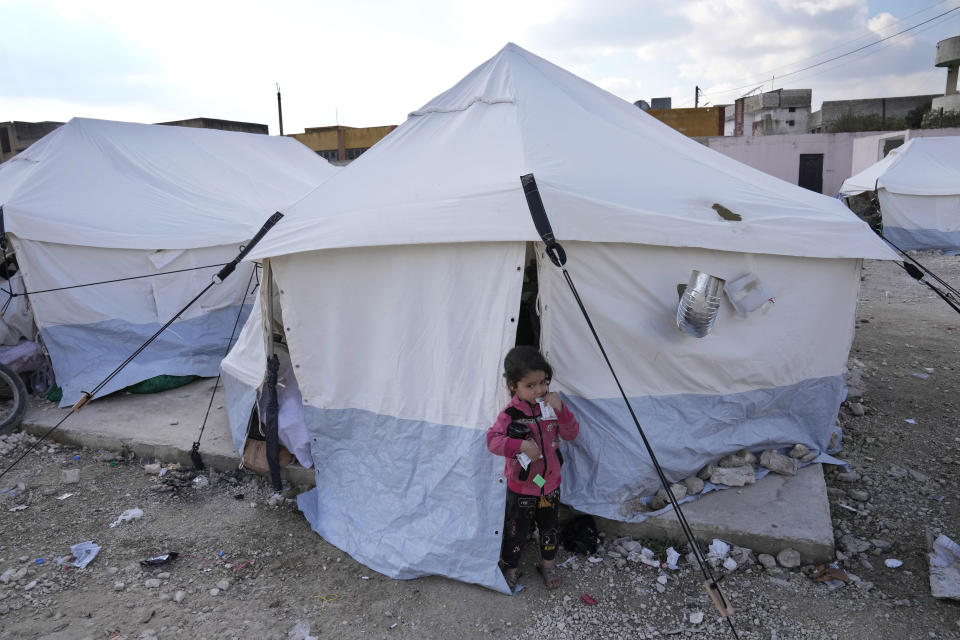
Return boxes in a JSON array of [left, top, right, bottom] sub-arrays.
[[487, 347, 580, 592]]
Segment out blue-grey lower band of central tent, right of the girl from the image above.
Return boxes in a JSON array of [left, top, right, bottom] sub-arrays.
[[562, 376, 846, 522]]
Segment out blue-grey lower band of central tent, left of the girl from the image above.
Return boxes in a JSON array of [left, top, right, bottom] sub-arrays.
[[297, 406, 508, 593]]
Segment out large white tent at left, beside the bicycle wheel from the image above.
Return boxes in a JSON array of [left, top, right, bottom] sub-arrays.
[[0, 118, 337, 404]]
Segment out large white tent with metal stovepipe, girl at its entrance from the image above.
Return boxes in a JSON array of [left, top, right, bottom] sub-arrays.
[[223, 44, 895, 591]]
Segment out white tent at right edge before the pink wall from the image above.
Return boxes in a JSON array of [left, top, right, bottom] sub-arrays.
[[840, 137, 960, 254]]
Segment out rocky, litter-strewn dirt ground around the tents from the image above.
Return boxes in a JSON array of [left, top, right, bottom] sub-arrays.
[[0, 254, 960, 640]]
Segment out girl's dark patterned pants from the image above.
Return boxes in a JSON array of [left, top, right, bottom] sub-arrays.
[[500, 489, 560, 569]]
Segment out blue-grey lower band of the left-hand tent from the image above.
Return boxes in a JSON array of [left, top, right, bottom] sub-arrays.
[[41, 305, 250, 407]]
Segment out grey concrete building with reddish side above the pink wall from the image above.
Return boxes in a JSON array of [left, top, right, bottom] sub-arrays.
[[724, 89, 813, 136]]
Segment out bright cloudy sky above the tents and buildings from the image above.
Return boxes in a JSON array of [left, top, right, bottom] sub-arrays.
[[0, 0, 960, 133]]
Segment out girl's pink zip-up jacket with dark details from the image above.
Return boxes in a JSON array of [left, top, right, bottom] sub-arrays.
[[487, 396, 580, 496]]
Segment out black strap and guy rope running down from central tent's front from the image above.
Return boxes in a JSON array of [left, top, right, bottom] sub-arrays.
[[520, 173, 740, 638]]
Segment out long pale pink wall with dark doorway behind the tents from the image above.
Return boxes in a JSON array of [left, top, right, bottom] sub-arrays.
[[697, 129, 960, 196]]
